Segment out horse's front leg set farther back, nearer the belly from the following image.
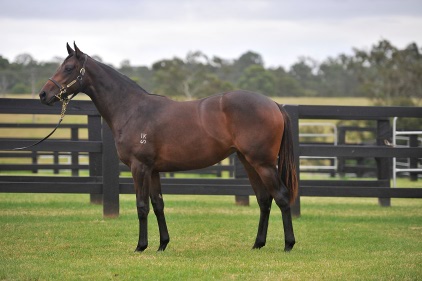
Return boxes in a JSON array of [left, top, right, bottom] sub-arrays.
[[150, 172, 170, 251]]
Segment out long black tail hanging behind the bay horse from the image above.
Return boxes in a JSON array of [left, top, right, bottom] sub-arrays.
[[278, 105, 298, 204]]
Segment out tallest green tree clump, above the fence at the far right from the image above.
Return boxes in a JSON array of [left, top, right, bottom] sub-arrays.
[[351, 40, 422, 105]]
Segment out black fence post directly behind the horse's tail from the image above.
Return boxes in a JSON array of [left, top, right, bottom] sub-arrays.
[[284, 105, 300, 217]]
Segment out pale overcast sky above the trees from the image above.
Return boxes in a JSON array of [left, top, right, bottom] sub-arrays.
[[0, 0, 422, 67]]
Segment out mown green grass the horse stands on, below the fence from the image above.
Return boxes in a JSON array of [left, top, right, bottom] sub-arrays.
[[0, 194, 422, 280]]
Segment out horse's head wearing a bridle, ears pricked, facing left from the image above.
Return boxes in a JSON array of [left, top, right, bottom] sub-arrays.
[[40, 44, 88, 105]]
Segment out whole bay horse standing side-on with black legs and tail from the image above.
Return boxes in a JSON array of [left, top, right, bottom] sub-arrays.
[[39, 44, 298, 252]]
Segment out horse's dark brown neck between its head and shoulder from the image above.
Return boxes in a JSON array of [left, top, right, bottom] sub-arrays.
[[86, 61, 148, 129]]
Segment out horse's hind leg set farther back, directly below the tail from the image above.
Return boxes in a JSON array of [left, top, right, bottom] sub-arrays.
[[255, 161, 295, 251]]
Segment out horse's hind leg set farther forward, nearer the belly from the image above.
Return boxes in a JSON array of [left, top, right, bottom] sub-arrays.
[[237, 153, 273, 249]]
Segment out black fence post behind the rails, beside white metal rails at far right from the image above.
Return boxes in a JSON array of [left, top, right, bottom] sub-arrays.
[[375, 119, 392, 207]]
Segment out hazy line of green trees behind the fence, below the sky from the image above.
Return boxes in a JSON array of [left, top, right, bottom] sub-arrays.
[[0, 40, 422, 106]]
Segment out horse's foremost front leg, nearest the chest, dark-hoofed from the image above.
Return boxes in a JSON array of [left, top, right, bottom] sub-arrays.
[[131, 164, 151, 252]]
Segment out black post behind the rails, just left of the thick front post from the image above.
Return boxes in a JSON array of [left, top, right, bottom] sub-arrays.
[[88, 115, 103, 204]]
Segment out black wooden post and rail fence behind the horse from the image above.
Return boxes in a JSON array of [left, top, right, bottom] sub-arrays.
[[0, 99, 422, 217]]
